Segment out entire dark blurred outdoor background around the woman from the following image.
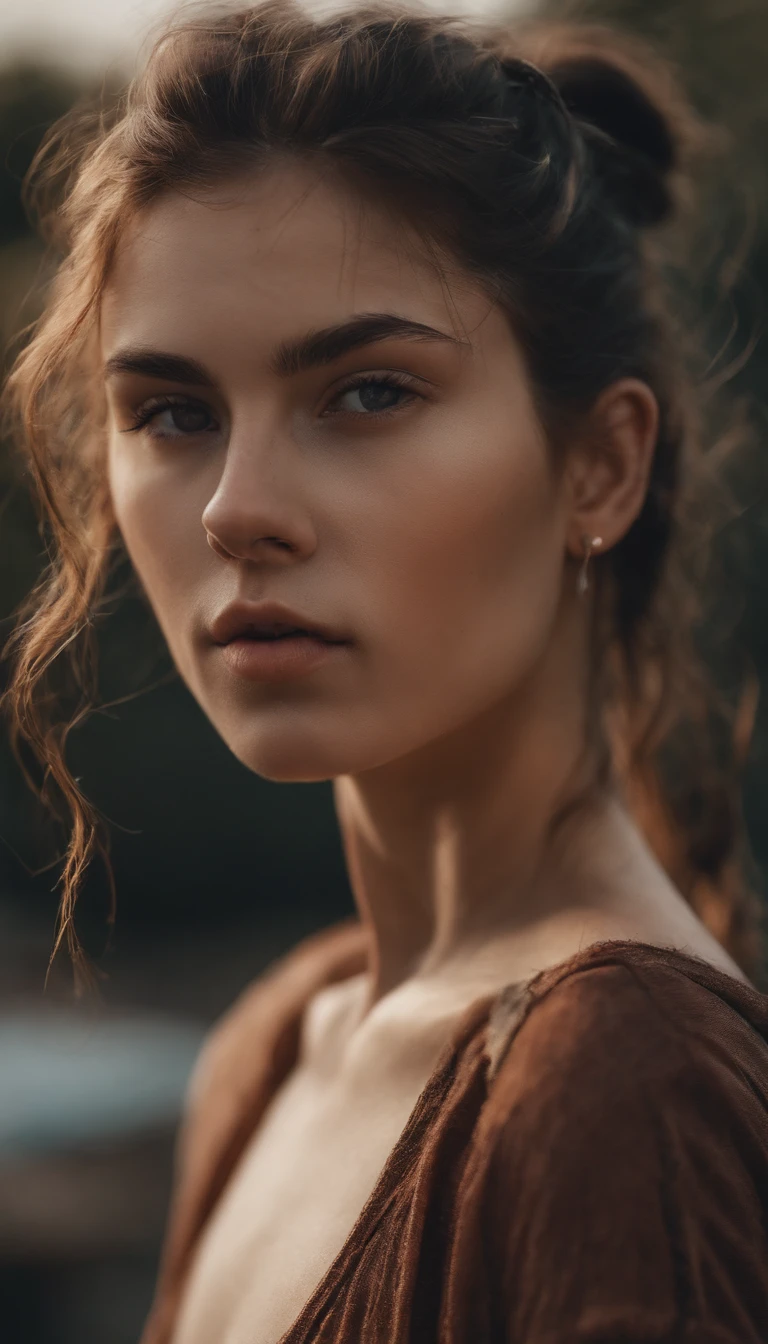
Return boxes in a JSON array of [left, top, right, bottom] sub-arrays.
[[0, 0, 768, 1344]]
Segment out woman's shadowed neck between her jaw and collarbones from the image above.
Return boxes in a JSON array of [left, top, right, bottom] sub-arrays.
[[334, 607, 613, 1007]]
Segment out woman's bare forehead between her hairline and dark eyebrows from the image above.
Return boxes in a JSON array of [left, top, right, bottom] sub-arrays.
[[101, 165, 503, 357]]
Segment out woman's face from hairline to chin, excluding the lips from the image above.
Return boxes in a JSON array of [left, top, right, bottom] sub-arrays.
[[101, 165, 568, 781]]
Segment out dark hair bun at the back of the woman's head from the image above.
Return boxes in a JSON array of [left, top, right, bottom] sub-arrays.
[[547, 55, 678, 226]]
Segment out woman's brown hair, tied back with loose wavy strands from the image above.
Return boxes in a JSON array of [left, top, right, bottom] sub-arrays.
[[3, 0, 759, 989]]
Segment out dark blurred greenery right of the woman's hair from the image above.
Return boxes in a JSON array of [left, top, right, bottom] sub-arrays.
[[538, 0, 768, 892]]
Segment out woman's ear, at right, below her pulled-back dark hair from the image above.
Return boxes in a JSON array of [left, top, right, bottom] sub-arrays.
[[566, 378, 659, 556]]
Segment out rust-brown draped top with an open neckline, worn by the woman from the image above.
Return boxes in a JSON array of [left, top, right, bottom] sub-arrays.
[[140, 919, 768, 1344]]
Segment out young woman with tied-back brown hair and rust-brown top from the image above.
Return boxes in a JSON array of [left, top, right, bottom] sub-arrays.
[[8, 0, 768, 1344]]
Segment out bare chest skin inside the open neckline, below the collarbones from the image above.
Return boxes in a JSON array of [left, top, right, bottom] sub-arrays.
[[174, 1059, 443, 1344]]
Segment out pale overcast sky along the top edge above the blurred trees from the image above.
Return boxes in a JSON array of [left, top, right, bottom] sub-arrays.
[[0, 0, 514, 70]]
